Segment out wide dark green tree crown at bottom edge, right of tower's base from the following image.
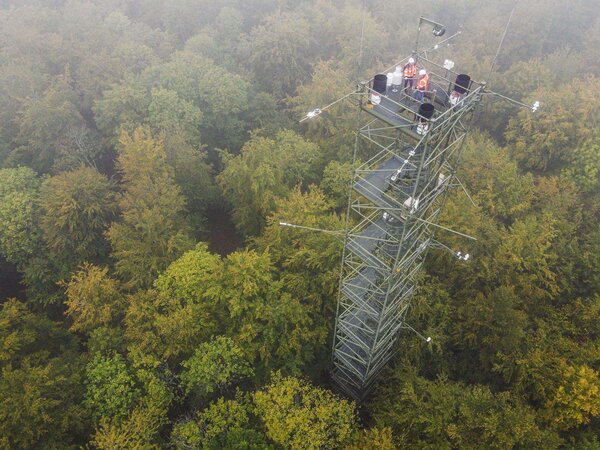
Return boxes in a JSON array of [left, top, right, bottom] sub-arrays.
[[370, 371, 560, 449]]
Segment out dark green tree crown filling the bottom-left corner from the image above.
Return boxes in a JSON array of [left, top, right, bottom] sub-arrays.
[[0, 299, 87, 449]]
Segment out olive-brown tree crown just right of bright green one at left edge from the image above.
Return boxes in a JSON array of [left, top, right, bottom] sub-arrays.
[[16, 166, 111, 304]]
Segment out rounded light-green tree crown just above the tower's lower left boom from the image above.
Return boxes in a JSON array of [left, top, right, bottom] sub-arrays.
[[217, 131, 318, 234]]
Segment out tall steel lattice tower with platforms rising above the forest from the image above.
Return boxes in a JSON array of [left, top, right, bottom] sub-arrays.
[[332, 18, 485, 400]]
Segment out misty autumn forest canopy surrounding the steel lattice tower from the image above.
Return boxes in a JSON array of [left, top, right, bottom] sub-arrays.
[[0, 0, 600, 450]]
